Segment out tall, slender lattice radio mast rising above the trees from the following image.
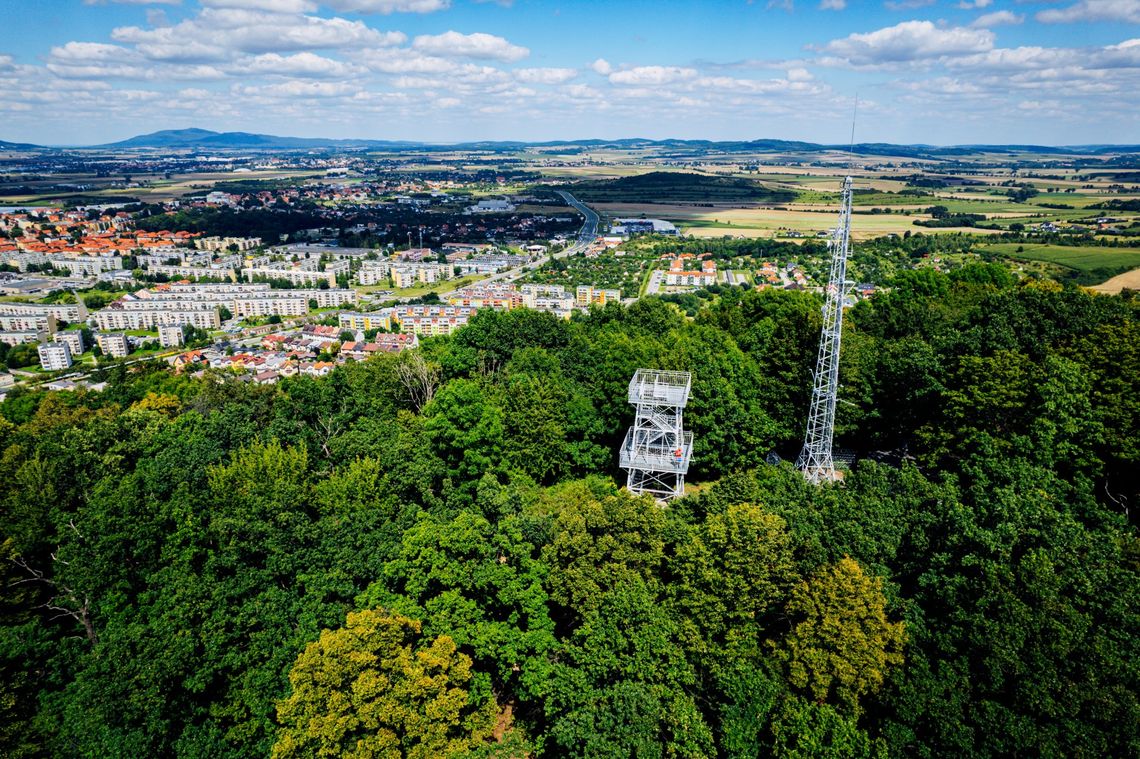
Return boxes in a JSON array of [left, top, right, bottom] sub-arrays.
[[796, 177, 852, 484]]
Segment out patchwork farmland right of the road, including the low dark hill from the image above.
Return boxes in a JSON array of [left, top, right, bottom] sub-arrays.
[[536, 152, 1140, 239]]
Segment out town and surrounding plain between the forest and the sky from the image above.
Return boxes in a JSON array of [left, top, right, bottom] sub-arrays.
[[0, 130, 1140, 393]]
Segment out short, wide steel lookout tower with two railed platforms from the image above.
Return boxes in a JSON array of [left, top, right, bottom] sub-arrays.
[[619, 369, 693, 500]]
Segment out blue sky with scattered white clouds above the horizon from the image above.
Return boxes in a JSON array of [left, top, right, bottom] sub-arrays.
[[0, 0, 1140, 145]]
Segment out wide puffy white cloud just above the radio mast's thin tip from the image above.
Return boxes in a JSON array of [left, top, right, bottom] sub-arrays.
[[823, 21, 994, 66]]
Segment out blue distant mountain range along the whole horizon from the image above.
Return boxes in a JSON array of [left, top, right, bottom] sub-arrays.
[[0, 129, 1140, 158]]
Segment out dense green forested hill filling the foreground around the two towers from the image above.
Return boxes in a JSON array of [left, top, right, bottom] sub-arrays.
[[0, 264, 1140, 758]]
